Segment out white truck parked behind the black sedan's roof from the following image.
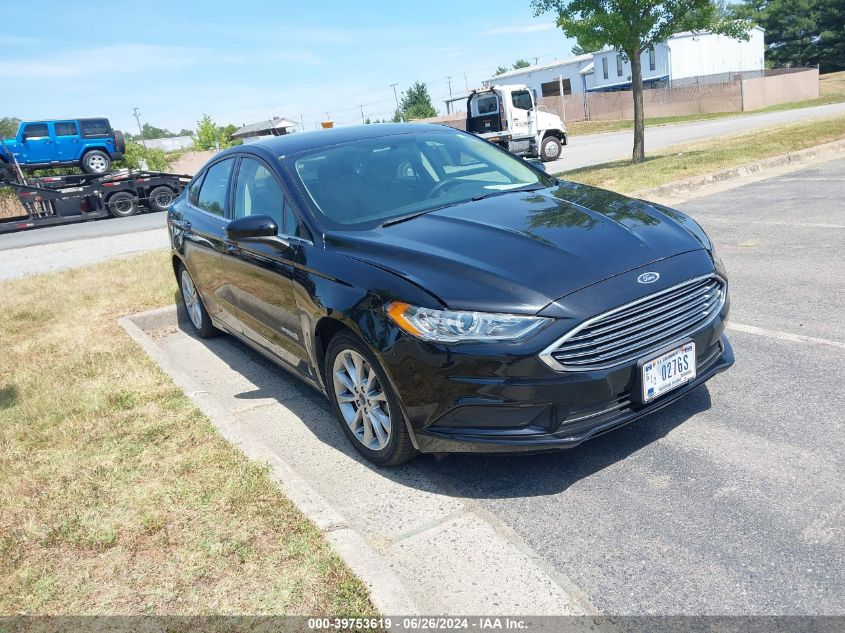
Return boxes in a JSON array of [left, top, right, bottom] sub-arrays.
[[466, 85, 567, 162]]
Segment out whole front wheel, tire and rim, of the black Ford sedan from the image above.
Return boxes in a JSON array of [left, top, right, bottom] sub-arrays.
[[325, 332, 417, 467]]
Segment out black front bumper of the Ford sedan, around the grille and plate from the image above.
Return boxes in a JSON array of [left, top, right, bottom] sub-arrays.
[[381, 252, 734, 453]]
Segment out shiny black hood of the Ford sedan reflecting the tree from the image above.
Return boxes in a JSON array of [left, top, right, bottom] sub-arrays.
[[326, 182, 703, 314]]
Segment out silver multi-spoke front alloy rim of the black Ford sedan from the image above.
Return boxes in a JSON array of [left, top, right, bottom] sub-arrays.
[[332, 348, 392, 451]]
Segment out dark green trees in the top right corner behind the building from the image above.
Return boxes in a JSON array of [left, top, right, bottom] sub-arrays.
[[731, 0, 845, 72]]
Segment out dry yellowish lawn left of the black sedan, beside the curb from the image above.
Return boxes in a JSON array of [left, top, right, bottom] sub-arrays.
[[0, 252, 374, 615]]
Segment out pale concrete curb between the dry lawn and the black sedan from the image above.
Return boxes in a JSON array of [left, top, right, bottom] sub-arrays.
[[118, 306, 420, 614]]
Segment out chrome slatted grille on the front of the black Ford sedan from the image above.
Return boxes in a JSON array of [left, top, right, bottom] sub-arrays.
[[541, 276, 725, 371]]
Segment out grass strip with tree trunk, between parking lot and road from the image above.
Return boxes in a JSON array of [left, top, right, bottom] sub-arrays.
[[560, 116, 845, 192]]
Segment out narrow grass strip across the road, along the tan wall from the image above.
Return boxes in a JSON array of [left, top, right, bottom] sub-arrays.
[[566, 71, 845, 136]]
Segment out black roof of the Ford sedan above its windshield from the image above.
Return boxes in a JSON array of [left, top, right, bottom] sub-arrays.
[[218, 123, 454, 157]]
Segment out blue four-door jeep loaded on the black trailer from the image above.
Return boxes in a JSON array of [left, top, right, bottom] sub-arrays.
[[0, 119, 126, 174]]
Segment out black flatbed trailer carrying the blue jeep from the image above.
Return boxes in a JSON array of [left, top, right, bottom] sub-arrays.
[[0, 165, 191, 233]]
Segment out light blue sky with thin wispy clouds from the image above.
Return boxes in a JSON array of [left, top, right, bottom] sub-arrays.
[[0, 0, 572, 131]]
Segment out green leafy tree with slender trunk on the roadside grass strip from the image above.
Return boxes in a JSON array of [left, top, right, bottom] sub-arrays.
[[531, 0, 750, 162]]
